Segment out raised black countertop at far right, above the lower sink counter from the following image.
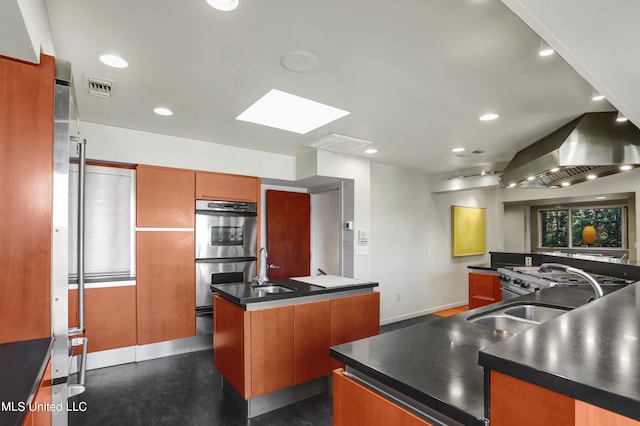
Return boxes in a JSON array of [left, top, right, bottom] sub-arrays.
[[479, 284, 640, 420]]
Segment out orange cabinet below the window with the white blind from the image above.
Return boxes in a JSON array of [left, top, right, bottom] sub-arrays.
[[69, 286, 136, 352]]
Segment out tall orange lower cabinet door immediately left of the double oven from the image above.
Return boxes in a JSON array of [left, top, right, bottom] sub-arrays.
[[136, 231, 196, 345]]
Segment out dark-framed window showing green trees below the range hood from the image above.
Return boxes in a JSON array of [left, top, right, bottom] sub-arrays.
[[539, 206, 627, 249]]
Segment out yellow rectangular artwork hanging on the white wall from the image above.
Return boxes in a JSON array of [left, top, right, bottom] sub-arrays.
[[451, 206, 486, 257]]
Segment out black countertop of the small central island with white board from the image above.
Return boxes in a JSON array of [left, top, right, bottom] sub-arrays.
[[211, 279, 378, 307]]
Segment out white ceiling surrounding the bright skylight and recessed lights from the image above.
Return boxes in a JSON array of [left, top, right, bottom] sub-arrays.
[[36, 0, 624, 174]]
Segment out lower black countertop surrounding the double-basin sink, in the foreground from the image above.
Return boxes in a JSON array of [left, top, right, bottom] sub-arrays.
[[330, 286, 616, 425]]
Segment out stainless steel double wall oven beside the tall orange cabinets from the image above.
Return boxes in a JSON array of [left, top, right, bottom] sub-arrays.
[[195, 200, 258, 334]]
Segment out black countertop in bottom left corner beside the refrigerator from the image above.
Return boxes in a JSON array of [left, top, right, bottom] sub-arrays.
[[0, 338, 53, 425]]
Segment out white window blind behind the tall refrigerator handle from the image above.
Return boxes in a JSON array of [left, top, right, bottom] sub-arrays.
[[69, 164, 135, 280]]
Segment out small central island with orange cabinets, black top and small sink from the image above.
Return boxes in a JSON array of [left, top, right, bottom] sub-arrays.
[[212, 276, 380, 418]]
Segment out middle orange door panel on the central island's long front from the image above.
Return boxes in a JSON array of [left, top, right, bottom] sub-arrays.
[[293, 300, 331, 384]]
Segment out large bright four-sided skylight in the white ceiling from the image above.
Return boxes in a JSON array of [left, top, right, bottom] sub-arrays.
[[236, 89, 351, 135]]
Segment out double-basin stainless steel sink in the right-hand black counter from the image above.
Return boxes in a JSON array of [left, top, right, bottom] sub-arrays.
[[467, 304, 568, 334]]
